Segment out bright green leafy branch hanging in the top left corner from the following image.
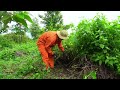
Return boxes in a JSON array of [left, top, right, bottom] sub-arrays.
[[0, 11, 33, 33]]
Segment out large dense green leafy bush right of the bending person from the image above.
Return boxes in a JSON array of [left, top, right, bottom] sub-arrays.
[[74, 14, 120, 72]]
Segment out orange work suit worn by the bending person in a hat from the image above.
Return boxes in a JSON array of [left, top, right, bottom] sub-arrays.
[[37, 31, 64, 69]]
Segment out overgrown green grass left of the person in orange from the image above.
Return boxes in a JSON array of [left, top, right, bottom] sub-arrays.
[[0, 41, 48, 79]]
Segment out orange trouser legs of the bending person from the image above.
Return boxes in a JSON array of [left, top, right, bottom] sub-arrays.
[[38, 45, 54, 69]]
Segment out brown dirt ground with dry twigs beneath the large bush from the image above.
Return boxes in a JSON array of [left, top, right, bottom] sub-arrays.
[[46, 58, 120, 79]]
